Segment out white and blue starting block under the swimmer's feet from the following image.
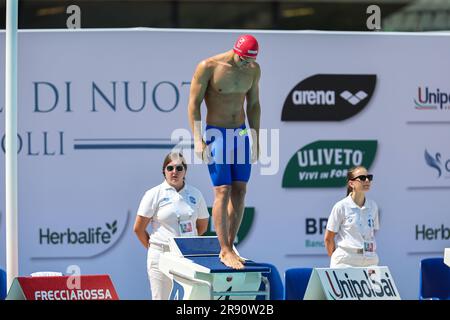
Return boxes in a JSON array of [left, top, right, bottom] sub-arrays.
[[159, 237, 270, 300]]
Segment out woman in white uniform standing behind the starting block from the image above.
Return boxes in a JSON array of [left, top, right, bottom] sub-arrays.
[[134, 153, 209, 300]]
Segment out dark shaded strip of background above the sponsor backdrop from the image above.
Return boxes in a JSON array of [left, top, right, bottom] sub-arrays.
[[0, 0, 450, 31]]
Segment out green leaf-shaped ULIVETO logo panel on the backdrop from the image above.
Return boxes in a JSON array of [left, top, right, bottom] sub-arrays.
[[282, 140, 378, 188]]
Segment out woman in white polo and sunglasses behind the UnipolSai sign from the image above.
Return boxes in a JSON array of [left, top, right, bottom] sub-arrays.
[[325, 166, 379, 268]]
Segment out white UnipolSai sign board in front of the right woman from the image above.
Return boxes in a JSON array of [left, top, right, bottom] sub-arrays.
[[325, 269, 399, 300]]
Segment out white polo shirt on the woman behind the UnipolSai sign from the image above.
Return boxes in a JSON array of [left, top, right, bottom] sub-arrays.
[[327, 195, 380, 250]]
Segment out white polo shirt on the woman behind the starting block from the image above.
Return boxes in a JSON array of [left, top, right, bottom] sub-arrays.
[[137, 180, 209, 244]]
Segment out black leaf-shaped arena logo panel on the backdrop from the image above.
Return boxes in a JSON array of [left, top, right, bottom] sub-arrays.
[[281, 74, 377, 121]]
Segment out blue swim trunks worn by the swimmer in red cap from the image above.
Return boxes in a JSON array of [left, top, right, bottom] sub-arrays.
[[205, 124, 251, 186]]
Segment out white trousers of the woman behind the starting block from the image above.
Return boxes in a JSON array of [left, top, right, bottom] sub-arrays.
[[147, 243, 172, 300]]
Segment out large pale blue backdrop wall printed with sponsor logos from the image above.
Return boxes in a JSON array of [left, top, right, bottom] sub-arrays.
[[0, 30, 450, 299]]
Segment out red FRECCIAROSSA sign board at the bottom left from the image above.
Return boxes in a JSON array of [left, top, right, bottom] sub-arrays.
[[7, 275, 119, 300]]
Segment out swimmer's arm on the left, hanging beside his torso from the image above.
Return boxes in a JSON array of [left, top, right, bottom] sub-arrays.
[[188, 61, 211, 151]]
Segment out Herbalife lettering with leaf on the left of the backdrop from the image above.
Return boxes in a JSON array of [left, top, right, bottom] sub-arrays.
[[39, 220, 117, 245]]
